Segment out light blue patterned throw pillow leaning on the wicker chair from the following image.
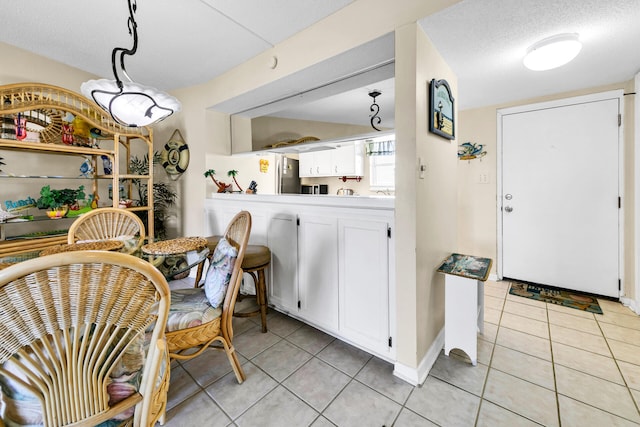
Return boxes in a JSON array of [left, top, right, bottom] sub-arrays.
[[204, 237, 238, 308]]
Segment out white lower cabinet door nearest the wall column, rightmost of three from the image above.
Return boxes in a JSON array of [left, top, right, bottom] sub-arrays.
[[338, 218, 391, 354]]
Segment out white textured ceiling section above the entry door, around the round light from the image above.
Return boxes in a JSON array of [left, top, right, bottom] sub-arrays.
[[420, 0, 640, 109]]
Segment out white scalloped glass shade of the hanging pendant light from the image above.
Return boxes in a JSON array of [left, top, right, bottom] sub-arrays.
[[80, 79, 181, 127]]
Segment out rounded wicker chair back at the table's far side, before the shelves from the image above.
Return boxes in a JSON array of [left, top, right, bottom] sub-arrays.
[[67, 208, 145, 253]]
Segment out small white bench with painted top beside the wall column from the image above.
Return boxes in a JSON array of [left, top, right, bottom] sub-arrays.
[[437, 254, 492, 366]]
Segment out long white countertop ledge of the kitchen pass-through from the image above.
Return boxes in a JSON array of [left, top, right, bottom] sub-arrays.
[[209, 193, 395, 210]]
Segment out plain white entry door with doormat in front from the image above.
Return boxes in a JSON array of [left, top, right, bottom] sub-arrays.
[[498, 97, 620, 297]]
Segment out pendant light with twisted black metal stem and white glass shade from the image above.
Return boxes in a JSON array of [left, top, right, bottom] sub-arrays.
[[80, 0, 180, 127]]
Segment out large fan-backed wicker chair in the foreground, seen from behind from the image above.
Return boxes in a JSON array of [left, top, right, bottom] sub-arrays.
[[0, 251, 170, 426]]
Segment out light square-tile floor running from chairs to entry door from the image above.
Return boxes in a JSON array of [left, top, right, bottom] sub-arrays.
[[165, 279, 640, 427]]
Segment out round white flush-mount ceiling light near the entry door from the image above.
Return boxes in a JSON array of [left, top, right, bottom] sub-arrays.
[[523, 33, 582, 71]]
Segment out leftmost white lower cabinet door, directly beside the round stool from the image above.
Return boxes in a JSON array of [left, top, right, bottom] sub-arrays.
[[267, 213, 298, 312]]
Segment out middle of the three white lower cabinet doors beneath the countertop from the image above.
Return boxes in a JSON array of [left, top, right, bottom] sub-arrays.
[[298, 214, 338, 331]]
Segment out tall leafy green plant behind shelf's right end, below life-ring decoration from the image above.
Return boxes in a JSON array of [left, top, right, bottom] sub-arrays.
[[129, 151, 178, 240]]
